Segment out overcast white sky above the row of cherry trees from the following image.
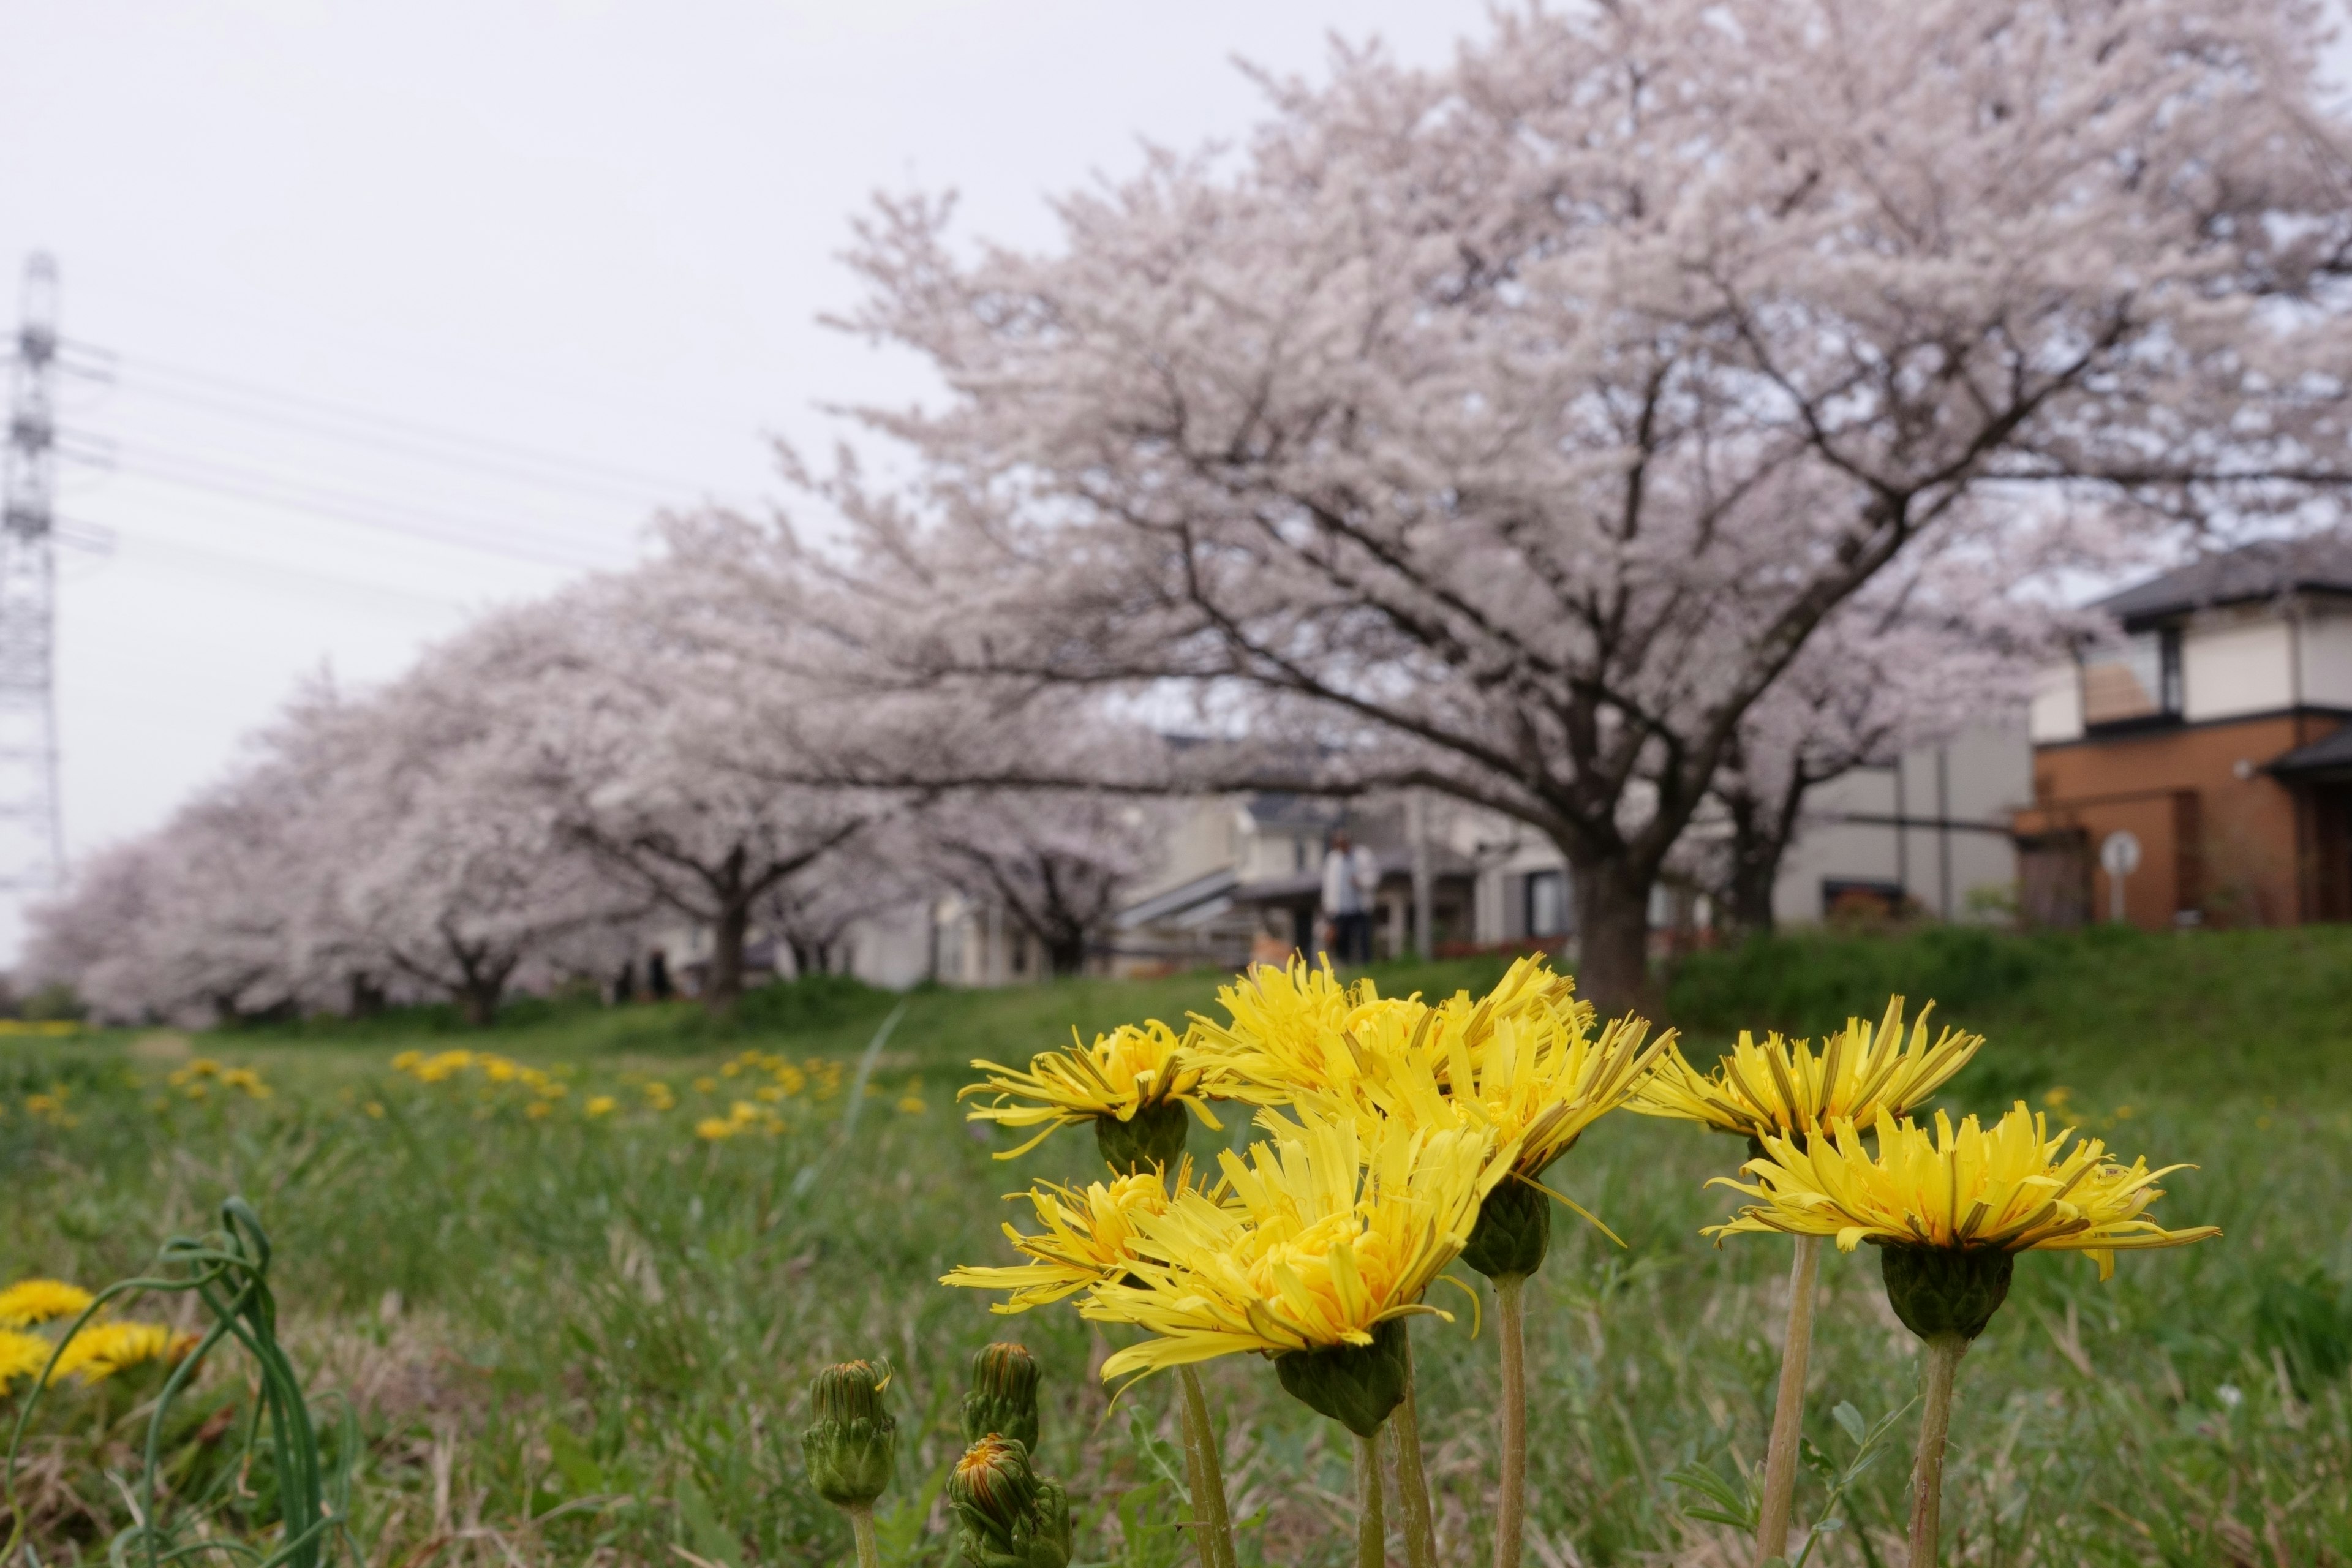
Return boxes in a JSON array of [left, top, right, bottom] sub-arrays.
[[0, 0, 1484, 957]]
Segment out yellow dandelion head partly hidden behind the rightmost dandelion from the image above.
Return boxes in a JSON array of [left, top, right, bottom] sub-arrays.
[[1627, 997, 1985, 1142]]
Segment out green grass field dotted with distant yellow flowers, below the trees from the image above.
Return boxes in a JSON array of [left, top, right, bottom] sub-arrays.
[[0, 929, 2352, 1568]]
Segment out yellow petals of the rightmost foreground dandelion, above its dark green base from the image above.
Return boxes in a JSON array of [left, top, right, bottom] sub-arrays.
[[1705, 1100, 2220, 1279]]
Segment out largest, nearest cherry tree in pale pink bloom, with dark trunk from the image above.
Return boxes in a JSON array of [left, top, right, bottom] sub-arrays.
[[816, 0, 2352, 1006]]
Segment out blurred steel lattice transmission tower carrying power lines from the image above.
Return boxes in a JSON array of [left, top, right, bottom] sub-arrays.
[[0, 254, 66, 893]]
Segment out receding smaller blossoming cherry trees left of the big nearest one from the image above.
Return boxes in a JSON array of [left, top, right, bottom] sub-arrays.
[[28, 527, 1171, 1023]]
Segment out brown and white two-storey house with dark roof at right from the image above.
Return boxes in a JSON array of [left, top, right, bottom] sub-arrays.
[[2013, 541, 2352, 929]]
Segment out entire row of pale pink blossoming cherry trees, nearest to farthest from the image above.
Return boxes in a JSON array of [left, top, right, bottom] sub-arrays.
[[45, 0, 2352, 1006]]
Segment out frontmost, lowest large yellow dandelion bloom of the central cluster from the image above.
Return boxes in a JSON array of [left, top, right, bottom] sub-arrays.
[[1080, 1105, 1506, 1378]]
